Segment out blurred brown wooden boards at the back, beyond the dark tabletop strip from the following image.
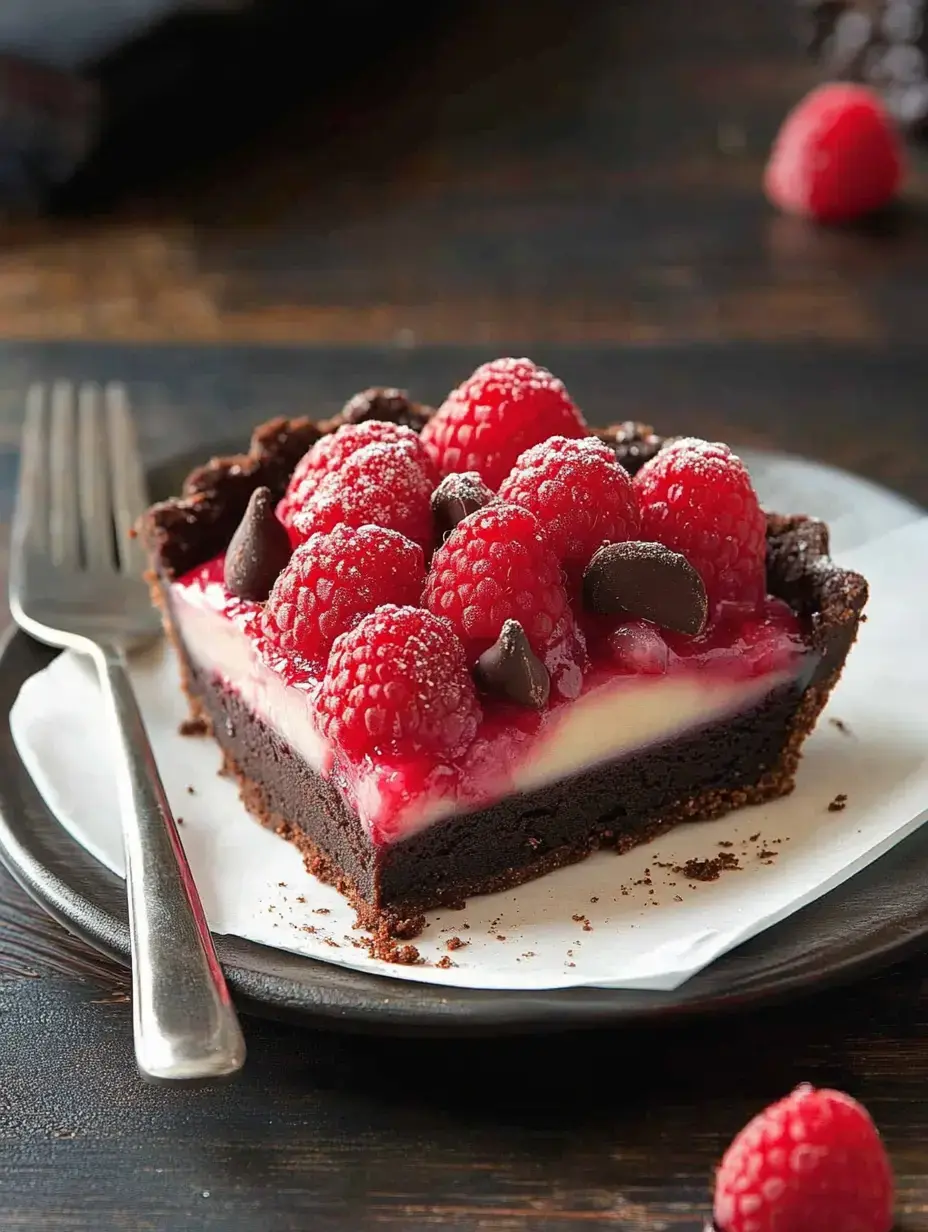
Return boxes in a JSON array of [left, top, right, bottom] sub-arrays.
[[0, 0, 928, 347]]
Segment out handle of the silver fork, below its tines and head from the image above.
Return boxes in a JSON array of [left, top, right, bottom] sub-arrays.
[[94, 646, 245, 1082]]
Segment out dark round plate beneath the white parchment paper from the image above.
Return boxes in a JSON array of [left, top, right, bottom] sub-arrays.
[[0, 456, 928, 1035]]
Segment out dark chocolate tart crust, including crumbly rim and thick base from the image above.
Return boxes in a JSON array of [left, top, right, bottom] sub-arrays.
[[139, 416, 868, 936]]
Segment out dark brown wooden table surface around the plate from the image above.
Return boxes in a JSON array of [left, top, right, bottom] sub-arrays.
[[0, 0, 928, 1232]]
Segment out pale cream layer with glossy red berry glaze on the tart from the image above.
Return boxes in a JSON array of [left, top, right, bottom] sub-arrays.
[[171, 556, 808, 843]]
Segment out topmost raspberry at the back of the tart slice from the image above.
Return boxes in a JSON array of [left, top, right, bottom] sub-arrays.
[[421, 360, 587, 490]]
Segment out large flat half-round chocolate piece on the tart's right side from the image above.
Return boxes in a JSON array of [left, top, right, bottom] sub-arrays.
[[583, 543, 709, 634]]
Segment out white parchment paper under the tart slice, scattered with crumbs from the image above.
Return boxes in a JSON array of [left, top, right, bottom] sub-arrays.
[[12, 458, 928, 989]]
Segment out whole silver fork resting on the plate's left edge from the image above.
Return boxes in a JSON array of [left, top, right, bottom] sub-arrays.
[[10, 382, 245, 1080]]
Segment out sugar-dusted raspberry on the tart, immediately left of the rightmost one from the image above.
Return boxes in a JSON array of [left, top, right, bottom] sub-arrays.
[[499, 436, 640, 573]]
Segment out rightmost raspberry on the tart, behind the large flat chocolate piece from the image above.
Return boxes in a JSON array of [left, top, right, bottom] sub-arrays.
[[632, 437, 767, 605]]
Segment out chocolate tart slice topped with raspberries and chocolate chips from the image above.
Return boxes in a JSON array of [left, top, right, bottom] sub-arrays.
[[140, 360, 866, 936]]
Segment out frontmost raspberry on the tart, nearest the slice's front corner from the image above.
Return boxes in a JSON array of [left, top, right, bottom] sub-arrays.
[[318, 604, 481, 759]]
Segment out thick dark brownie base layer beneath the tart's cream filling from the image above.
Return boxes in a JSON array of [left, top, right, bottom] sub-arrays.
[[178, 655, 827, 938]]
